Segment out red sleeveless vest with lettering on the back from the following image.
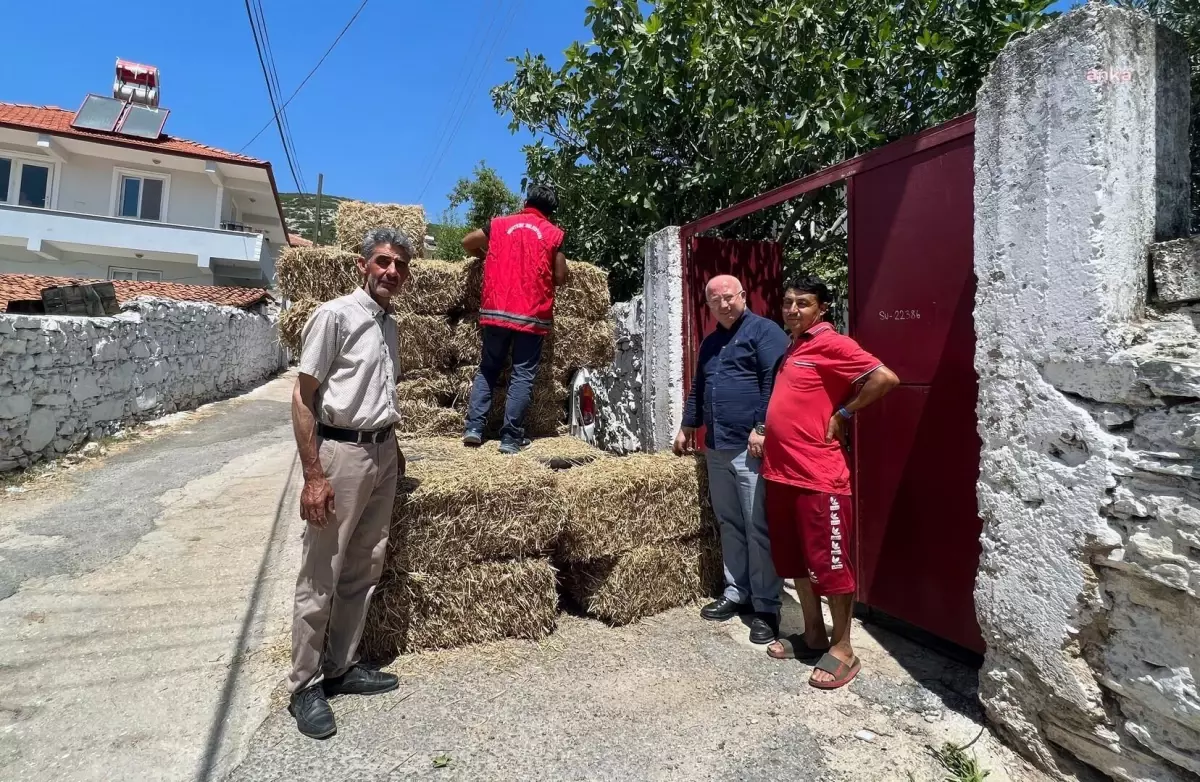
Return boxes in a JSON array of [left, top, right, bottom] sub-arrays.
[[479, 206, 564, 335]]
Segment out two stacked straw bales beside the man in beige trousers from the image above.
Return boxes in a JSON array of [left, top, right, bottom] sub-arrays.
[[364, 438, 565, 660]]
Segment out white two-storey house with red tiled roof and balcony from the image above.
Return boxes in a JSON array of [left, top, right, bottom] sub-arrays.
[[0, 71, 288, 287]]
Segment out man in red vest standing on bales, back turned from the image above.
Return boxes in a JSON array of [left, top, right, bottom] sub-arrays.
[[462, 185, 566, 453]]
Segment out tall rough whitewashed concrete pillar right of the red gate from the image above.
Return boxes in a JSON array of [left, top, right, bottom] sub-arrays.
[[974, 4, 1189, 782]]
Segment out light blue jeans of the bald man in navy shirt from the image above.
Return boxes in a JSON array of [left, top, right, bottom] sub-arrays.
[[704, 449, 784, 614]]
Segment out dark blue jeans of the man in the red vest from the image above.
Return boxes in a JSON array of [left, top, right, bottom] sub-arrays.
[[467, 326, 546, 440]]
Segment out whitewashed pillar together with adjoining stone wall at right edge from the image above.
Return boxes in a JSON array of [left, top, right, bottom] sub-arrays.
[[974, 4, 1200, 782]]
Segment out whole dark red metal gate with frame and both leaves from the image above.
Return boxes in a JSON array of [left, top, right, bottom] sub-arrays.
[[680, 115, 983, 651]]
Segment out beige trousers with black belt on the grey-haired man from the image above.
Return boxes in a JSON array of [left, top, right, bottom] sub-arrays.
[[288, 439, 400, 692]]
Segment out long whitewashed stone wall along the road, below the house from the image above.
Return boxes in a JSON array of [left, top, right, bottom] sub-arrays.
[[0, 297, 286, 470]]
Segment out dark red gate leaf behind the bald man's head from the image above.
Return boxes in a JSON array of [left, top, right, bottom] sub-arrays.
[[683, 236, 784, 447]]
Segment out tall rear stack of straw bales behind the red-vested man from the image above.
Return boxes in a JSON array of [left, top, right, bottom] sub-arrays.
[[276, 201, 614, 446]]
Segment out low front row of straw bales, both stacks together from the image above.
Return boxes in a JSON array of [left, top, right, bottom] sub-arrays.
[[364, 437, 721, 661]]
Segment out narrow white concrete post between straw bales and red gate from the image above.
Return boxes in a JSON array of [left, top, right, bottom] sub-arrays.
[[641, 227, 684, 452]]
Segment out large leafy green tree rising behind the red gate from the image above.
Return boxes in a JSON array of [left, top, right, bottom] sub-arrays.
[[492, 0, 1050, 297]]
